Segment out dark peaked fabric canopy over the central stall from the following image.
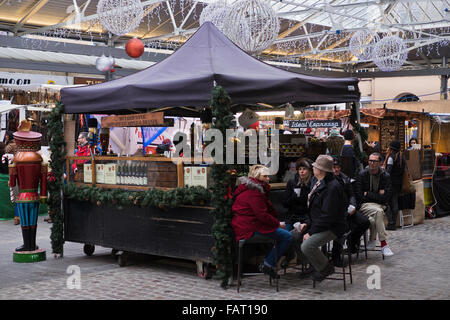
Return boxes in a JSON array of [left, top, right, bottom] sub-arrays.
[[61, 22, 360, 114]]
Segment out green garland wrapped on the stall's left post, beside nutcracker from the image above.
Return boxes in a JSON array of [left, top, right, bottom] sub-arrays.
[[48, 101, 66, 256]]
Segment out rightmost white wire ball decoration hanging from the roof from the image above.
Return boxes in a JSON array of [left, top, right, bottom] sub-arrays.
[[373, 35, 408, 72]]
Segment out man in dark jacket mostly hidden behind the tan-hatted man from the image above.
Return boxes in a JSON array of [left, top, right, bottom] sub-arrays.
[[332, 158, 370, 267]]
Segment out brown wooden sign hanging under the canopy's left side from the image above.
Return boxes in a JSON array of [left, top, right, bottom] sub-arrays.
[[102, 112, 169, 128]]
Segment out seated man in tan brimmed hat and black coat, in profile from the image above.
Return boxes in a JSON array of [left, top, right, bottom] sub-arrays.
[[301, 155, 347, 282]]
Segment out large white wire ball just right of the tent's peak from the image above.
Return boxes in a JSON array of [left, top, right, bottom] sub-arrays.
[[225, 0, 280, 54]]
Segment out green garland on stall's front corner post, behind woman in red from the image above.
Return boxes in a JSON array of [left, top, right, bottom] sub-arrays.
[[211, 86, 235, 288]]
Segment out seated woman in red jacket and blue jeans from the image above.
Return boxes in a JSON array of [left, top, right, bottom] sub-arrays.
[[232, 165, 292, 277]]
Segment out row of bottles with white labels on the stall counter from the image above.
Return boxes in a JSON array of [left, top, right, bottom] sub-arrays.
[[117, 161, 148, 186]]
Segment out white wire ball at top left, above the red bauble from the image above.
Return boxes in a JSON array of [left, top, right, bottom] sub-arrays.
[[97, 0, 144, 36]]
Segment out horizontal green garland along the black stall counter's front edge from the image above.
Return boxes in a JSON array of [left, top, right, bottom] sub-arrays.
[[64, 182, 211, 210]]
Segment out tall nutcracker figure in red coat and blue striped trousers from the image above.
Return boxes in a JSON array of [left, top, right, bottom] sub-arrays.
[[9, 120, 47, 253]]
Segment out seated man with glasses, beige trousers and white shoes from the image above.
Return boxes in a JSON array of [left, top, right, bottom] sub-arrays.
[[355, 153, 394, 256]]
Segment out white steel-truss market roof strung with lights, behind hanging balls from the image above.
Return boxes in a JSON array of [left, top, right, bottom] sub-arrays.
[[0, 0, 450, 72]]
